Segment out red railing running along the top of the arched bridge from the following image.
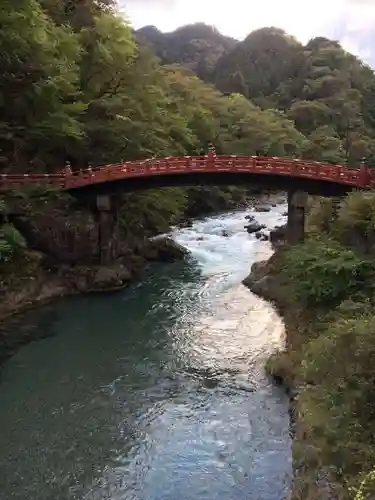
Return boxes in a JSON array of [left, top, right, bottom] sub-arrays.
[[0, 153, 375, 189]]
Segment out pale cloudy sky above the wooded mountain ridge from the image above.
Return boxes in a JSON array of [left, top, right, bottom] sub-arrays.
[[119, 0, 375, 67]]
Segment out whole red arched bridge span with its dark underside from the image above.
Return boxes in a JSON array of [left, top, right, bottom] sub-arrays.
[[0, 153, 375, 195]]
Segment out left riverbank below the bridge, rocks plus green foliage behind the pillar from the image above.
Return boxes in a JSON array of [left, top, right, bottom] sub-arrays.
[[0, 188, 256, 323]]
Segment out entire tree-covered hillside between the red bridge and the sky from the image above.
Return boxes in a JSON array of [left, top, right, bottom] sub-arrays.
[[0, 0, 375, 181]]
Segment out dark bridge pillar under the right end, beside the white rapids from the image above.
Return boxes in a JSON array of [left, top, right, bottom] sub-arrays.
[[287, 190, 307, 245]]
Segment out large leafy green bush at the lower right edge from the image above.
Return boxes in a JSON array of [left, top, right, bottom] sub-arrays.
[[301, 316, 375, 479]]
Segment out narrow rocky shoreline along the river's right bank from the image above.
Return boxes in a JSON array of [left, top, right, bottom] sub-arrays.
[[243, 226, 342, 500]]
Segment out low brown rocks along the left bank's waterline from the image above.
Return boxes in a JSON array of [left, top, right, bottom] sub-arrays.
[[0, 237, 188, 365]]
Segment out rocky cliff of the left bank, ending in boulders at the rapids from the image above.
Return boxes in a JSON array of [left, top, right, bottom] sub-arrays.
[[0, 189, 186, 319]]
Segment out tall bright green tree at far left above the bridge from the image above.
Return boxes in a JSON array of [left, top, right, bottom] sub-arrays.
[[0, 0, 83, 167]]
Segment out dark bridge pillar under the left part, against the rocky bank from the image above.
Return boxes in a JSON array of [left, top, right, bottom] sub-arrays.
[[96, 194, 118, 265]]
